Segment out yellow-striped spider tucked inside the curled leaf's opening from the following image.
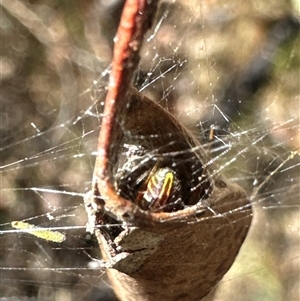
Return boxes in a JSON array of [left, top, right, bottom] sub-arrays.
[[138, 167, 180, 211]]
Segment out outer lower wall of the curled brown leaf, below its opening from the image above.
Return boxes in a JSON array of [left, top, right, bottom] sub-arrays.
[[97, 182, 251, 301]]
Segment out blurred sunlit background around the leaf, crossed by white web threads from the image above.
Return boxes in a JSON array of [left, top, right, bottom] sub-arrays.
[[0, 0, 300, 301]]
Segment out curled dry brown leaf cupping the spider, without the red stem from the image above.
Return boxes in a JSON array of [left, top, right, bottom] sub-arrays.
[[86, 90, 252, 301]]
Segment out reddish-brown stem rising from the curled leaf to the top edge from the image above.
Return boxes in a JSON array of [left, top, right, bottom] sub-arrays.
[[94, 0, 157, 179]]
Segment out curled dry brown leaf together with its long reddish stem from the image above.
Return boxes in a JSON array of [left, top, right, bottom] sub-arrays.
[[85, 0, 252, 301]]
